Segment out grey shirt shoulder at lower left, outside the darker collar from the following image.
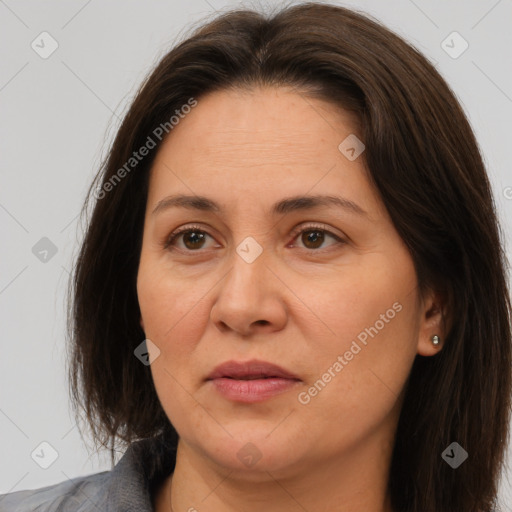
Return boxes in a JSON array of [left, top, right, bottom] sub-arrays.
[[0, 471, 111, 512]]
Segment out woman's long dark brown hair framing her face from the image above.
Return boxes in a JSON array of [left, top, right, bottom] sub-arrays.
[[69, 3, 512, 512]]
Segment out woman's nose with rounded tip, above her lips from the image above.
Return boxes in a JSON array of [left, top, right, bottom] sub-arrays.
[[210, 247, 287, 337]]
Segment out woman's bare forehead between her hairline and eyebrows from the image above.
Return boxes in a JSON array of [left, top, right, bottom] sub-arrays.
[[145, 88, 384, 218]]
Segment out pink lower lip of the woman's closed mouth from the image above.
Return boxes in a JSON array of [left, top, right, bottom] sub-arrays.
[[211, 377, 299, 403]]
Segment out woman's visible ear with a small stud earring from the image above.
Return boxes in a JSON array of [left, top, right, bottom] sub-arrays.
[[417, 291, 448, 356]]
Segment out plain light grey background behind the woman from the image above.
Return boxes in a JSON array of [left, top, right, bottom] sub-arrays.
[[0, 0, 512, 510]]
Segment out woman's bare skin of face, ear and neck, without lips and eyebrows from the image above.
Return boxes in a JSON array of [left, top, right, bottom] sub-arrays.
[[137, 87, 443, 512]]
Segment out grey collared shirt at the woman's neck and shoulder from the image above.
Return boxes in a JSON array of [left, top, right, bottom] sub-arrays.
[[0, 437, 176, 512]]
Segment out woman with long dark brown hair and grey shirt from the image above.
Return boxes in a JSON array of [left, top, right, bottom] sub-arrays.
[[0, 3, 512, 512]]
